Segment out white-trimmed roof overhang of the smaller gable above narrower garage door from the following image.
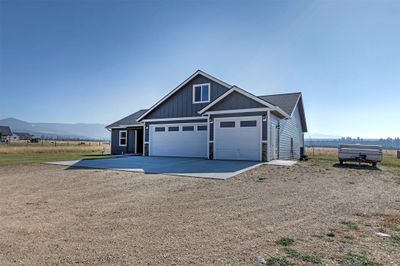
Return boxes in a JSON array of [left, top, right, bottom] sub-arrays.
[[198, 86, 290, 118]]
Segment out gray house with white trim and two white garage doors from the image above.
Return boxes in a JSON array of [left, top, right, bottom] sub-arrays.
[[106, 70, 307, 161]]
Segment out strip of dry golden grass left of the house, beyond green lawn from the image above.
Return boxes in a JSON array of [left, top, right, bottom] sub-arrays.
[[0, 141, 110, 154]]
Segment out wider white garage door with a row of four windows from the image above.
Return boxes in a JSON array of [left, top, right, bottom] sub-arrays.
[[149, 123, 207, 158]]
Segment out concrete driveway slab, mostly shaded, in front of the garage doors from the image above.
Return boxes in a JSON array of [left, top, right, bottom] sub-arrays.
[[48, 156, 262, 179]]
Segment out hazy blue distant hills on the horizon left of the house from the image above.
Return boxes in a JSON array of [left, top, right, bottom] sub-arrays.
[[0, 118, 110, 140]]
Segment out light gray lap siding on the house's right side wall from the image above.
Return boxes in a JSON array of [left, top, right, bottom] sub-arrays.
[[279, 107, 304, 160]]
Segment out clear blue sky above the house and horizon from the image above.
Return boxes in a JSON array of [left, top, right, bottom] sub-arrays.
[[0, 0, 400, 137]]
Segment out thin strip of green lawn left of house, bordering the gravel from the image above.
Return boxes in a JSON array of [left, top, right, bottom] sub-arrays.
[[0, 151, 110, 166]]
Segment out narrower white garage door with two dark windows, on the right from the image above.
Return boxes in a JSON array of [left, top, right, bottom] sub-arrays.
[[214, 117, 262, 161]]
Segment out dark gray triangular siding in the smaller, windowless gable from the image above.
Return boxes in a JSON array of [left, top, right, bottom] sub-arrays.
[[209, 91, 266, 111]]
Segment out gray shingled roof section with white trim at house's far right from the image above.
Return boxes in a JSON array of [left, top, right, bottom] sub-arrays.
[[258, 92, 307, 132]]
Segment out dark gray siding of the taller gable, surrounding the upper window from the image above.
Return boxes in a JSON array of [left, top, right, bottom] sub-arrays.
[[144, 75, 228, 119]]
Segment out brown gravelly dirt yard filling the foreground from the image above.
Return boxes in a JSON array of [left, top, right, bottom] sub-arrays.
[[0, 161, 400, 265]]
